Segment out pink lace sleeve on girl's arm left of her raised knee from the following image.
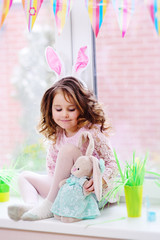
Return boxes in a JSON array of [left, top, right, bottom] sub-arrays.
[[46, 143, 58, 175]]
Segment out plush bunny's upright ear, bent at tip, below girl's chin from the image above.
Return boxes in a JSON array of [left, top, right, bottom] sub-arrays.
[[78, 131, 94, 156]]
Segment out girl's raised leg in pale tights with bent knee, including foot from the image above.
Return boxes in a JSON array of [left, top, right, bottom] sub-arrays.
[[22, 144, 82, 221]]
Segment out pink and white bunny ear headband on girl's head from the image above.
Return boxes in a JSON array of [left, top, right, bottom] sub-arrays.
[[46, 46, 89, 88]]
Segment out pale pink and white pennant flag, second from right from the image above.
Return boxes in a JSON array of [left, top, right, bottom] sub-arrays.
[[112, 0, 137, 37]]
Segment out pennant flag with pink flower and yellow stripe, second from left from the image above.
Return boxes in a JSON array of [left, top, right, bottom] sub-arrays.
[[22, 0, 43, 31]]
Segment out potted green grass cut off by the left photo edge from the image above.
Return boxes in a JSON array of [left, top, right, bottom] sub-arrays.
[[0, 160, 18, 202]]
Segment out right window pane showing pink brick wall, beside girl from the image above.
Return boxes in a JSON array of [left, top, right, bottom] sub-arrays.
[[96, 4, 160, 171]]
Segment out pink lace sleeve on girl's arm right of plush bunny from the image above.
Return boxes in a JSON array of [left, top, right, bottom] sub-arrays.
[[92, 128, 118, 202]]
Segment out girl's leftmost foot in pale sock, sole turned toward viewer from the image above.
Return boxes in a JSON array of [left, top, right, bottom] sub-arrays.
[[8, 204, 33, 221]]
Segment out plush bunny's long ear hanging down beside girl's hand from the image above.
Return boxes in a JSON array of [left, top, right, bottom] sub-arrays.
[[90, 156, 102, 201]]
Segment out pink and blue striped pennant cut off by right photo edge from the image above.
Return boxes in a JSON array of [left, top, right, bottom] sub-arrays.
[[145, 0, 160, 35]]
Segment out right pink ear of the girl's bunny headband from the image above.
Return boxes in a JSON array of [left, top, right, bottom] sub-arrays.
[[74, 46, 89, 73]]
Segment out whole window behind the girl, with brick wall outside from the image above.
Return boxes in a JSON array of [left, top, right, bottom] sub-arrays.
[[0, 0, 160, 176]]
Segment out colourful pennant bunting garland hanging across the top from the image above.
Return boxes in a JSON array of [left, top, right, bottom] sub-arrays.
[[0, 0, 160, 37]]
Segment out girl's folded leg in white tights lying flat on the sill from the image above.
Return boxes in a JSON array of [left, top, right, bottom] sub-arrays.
[[8, 172, 52, 221]]
